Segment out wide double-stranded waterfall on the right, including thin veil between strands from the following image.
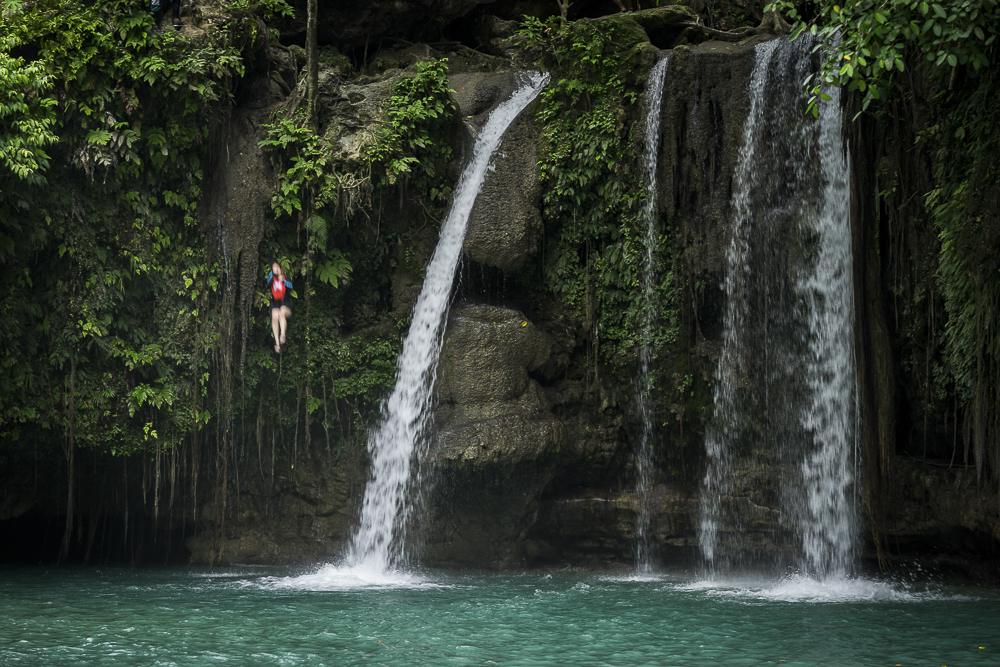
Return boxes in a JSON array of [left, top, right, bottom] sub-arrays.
[[699, 36, 857, 577]]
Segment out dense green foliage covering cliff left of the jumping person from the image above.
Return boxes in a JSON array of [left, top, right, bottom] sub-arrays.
[[0, 0, 270, 454]]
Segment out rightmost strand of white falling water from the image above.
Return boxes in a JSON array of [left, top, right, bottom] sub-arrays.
[[798, 81, 858, 576]]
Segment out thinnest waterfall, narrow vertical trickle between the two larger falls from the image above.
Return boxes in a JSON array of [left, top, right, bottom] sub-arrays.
[[635, 57, 669, 572]]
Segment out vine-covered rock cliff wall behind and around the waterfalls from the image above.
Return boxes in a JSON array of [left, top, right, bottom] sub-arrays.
[[0, 0, 1000, 567]]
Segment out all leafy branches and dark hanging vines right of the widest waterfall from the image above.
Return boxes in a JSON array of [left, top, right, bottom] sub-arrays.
[[769, 0, 1000, 498]]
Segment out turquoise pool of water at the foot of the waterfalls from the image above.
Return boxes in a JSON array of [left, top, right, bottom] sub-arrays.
[[0, 566, 1000, 667]]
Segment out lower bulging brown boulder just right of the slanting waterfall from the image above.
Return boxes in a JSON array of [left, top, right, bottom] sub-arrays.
[[424, 305, 565, 568]]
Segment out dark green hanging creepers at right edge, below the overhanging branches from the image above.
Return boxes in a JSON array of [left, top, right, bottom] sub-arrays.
[[921, 69, 1000, 477]]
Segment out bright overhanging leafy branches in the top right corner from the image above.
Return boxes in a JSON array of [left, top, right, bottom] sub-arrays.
[[768, 0, 1000, 114]]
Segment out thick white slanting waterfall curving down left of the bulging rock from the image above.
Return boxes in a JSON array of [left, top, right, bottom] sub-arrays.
[[347, 73, 549, 573]]
